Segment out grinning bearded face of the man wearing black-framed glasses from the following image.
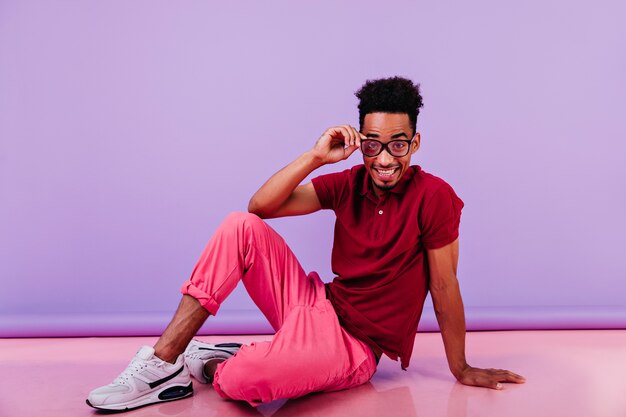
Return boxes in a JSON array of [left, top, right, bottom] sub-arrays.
[[361, 113, 420, 195]]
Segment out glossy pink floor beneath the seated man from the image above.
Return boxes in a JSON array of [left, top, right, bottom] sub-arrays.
[[0, 330, 626, 417]]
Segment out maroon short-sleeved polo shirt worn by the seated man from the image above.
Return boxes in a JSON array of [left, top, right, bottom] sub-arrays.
[[312, 165, 463, 369]]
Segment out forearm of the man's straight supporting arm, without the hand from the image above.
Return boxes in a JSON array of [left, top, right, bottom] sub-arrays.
[[430, 279, 468, 379]]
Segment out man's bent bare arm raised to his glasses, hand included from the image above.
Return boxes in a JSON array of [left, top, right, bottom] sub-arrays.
[[248, 125, 362, 218]]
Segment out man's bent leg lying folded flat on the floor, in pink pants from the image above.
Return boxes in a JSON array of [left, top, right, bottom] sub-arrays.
[[213, 298, 376, 406]]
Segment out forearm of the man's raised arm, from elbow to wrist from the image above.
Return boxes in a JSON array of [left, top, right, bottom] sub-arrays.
[[248, 151, 323, 217]]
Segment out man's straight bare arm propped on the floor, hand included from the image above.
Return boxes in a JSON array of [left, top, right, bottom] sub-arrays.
[[427, 239, 525, 389]]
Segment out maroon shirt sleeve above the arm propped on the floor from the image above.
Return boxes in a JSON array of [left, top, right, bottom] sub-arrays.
[[419, 184, 463, 249]]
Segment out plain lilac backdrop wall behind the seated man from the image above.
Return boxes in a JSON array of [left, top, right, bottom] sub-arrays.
[[0, 0, 626, 336]]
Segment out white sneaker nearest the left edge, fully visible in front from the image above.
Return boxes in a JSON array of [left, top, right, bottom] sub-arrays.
[[87, 346, 193, 411]]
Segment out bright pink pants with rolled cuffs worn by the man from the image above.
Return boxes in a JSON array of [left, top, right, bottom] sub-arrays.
[[181, 213, 376, 406]]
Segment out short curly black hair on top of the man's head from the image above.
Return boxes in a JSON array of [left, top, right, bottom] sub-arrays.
[[354, 76, 424, 133]]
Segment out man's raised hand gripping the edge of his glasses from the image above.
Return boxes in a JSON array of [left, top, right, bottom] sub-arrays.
[[312, 125, 365, 164]]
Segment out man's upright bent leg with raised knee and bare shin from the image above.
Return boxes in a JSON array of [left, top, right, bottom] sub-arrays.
[[155, 213, 316, 362]]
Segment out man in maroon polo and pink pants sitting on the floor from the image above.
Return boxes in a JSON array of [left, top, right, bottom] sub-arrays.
[[87, 77, 524, 410]]
